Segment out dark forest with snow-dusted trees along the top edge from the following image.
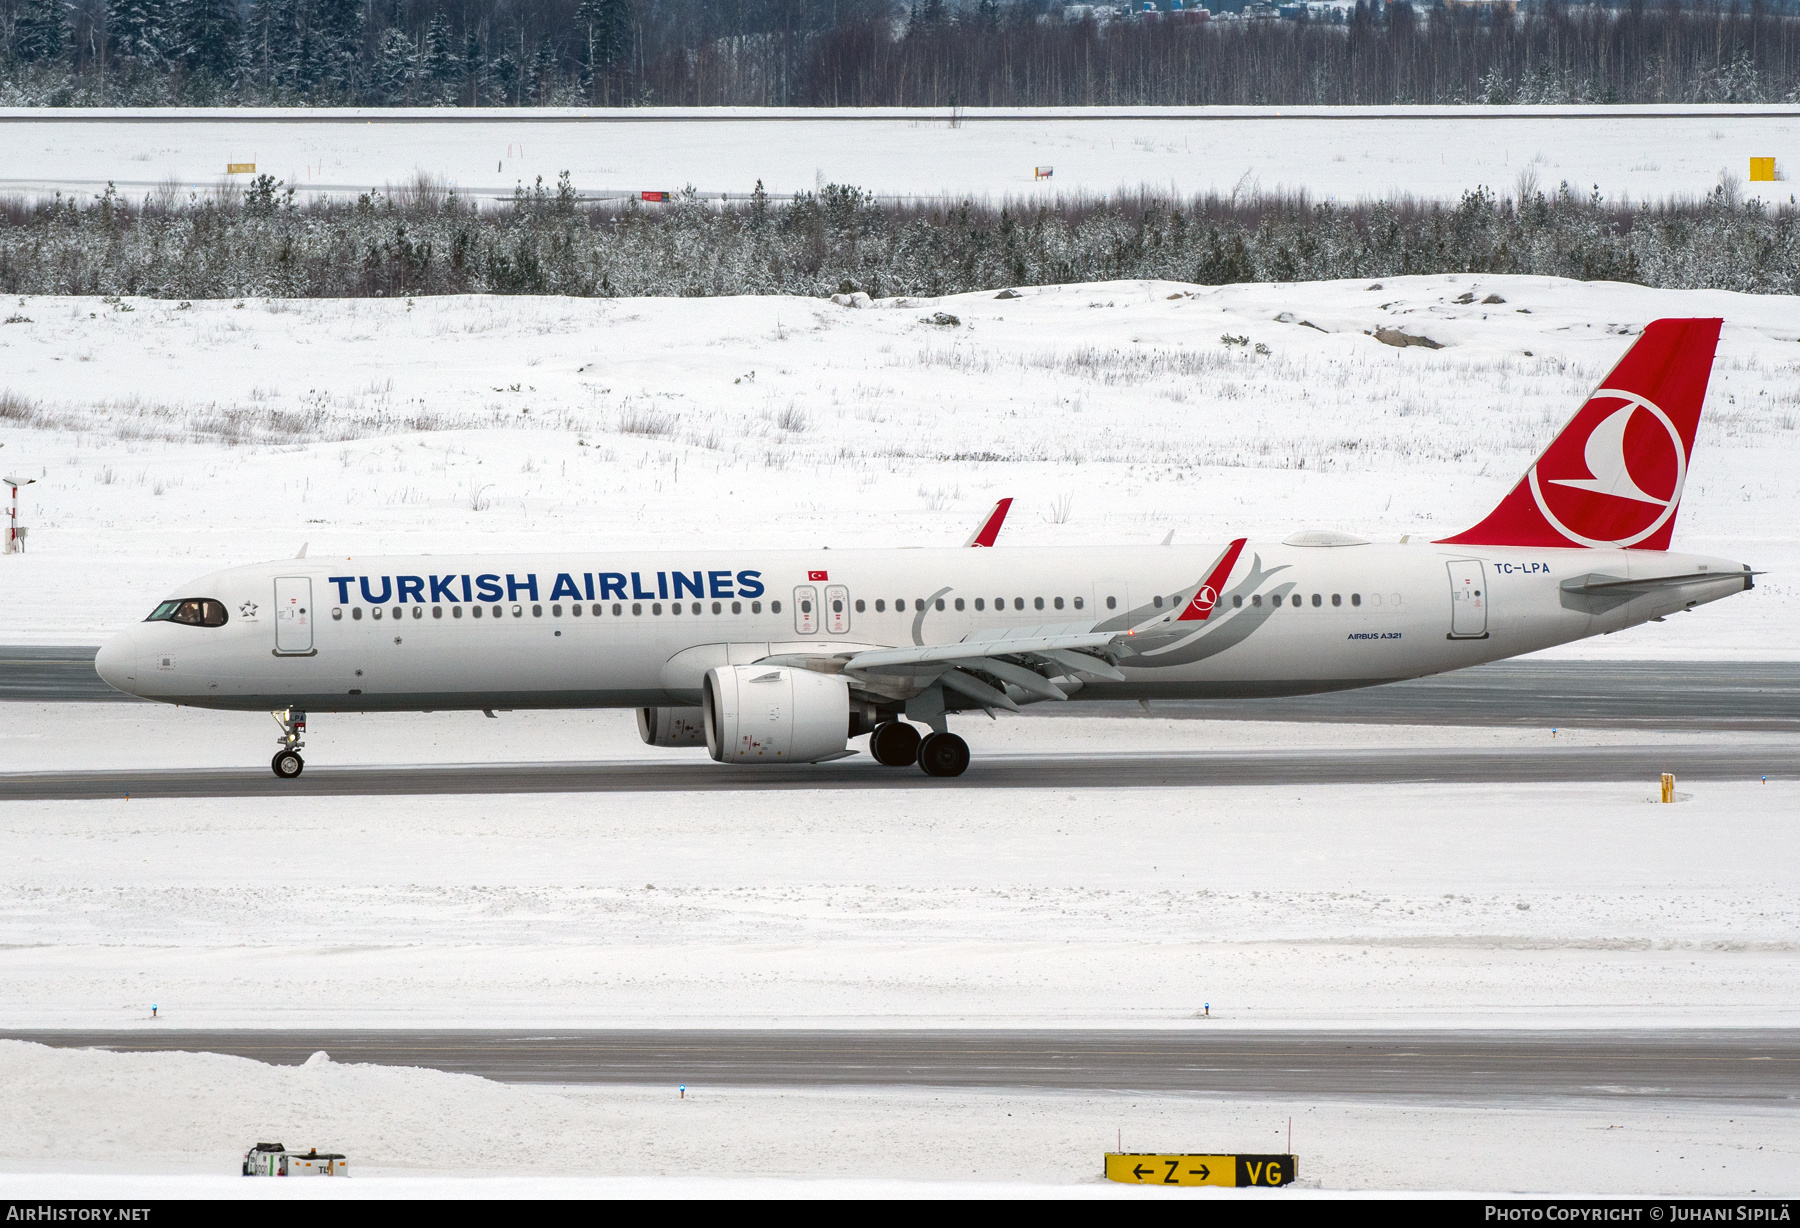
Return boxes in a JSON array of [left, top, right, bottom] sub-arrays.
[[0, 0, 1800, 106]]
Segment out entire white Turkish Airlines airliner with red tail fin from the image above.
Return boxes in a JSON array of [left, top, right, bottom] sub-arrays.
[[95, 321, 1753, 778]]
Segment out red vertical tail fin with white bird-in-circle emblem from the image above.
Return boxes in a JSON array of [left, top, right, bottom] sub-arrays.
[[1442, 321, 1724, 549]]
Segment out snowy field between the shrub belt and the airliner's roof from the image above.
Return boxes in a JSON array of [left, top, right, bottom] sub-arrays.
[[0, 275, 1800, 659]]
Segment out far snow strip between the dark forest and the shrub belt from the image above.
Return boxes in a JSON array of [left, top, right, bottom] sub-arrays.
[[0, 104, 1800, 202]]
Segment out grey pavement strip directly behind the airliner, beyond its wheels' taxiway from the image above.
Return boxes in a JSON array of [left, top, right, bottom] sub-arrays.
[[10, 645, 1800, 731]]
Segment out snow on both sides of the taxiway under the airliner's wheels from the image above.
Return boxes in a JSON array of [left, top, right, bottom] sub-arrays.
[[0, 704, 1800, 1028]]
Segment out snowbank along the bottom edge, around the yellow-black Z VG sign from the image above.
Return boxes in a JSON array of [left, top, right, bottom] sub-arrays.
[[0, 1041, 1800, 1199]]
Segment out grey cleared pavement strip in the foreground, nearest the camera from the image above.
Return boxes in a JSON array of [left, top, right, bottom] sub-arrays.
[[0, 1021, 1800, 1104]]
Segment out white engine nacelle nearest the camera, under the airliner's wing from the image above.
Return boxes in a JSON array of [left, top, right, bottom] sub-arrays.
[[700, 664, 850, 763]]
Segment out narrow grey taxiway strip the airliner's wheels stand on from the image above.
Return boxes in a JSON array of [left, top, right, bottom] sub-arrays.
[[0, 745, 1800, 801]]
